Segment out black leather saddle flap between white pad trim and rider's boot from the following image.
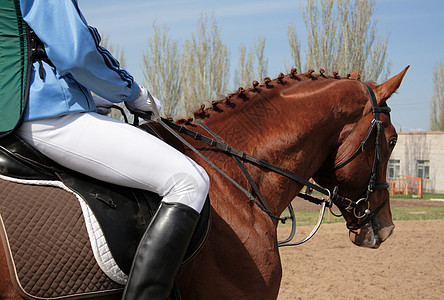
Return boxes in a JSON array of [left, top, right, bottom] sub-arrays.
[[57, 173, 161, 274]]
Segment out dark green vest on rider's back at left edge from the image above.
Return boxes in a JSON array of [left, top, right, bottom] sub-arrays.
[[0, 0, 32, 137]]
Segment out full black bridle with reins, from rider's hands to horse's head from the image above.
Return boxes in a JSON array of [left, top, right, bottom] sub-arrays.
[[132, 82, 391, 246]]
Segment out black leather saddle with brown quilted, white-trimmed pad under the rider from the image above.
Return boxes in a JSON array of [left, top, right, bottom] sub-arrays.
[[0, 128, 211, 299]]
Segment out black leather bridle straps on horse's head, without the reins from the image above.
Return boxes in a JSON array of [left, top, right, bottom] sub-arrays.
[[328, 82, 391, 230]]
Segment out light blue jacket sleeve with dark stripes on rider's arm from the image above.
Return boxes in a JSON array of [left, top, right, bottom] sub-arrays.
[[20, 0, 139, 102]]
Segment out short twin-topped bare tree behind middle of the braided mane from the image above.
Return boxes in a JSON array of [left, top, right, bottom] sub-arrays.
[[235, 36, 268, 87]]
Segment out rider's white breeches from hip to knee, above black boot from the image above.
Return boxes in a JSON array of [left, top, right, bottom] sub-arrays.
[[17, 113, 209, 213]]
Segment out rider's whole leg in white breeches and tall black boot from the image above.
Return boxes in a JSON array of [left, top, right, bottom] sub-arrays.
[[18, 113, 209, 299]]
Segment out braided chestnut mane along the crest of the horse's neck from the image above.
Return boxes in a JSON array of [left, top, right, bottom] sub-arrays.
[[177, 68, 361, 125]]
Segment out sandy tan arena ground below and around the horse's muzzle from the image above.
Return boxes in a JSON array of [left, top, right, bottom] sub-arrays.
[[278, 200, 444, 300]]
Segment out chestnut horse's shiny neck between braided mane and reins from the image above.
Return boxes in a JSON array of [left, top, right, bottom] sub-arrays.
[[191, 75, 364, 215]]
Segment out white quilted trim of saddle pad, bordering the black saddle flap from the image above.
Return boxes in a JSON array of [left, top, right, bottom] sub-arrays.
[[0, 175, 128, 285]]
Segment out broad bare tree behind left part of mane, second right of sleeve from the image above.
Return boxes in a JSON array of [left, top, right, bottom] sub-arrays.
[[181, 13, 229, 115]]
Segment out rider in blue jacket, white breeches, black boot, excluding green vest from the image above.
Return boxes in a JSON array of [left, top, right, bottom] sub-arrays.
[[17, 0, 209, 299]]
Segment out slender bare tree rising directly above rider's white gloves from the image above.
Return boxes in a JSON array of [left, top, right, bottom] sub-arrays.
[[143, 21, 182, 117]]
